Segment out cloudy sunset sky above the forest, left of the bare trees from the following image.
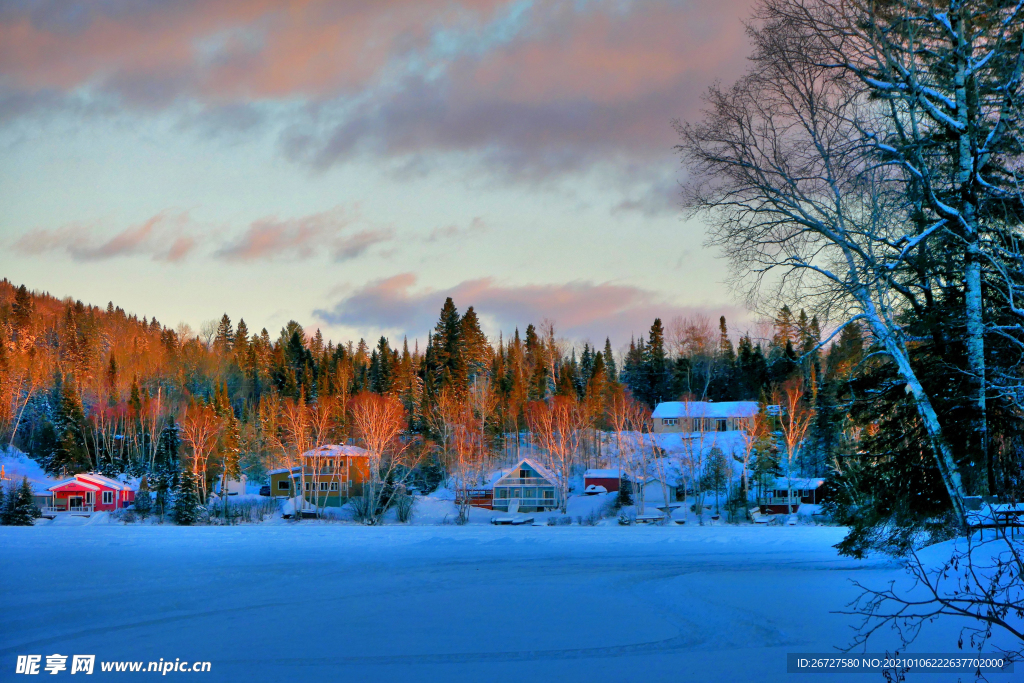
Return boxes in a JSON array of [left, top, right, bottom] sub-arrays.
[[0, 0, 752, 345]]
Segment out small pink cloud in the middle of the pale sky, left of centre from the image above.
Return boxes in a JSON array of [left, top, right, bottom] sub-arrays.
[[214, 207, 394, 261]]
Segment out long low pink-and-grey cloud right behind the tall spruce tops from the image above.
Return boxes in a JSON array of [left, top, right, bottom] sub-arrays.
[[314, 272, 748, 344]]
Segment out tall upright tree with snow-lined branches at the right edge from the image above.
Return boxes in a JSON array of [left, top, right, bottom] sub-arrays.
[[761, 0, 1024, 495]]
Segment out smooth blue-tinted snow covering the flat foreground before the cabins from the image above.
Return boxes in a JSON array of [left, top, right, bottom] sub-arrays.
[[0, 522, 995, 683]]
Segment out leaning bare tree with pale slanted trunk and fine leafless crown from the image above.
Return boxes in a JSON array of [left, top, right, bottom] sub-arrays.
[[677, 9, 966, 520]]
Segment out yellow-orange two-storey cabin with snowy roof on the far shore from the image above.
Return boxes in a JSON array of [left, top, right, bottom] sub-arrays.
[[269, 444, 371, 509]]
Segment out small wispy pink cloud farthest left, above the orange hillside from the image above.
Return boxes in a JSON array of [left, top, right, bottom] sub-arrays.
[[13, 212, 197, 262]]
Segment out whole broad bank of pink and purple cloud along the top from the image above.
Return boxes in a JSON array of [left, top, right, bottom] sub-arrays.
[[0, 0, 753, 188]]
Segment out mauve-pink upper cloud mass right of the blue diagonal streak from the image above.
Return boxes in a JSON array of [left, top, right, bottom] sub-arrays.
[[283, 0, 750, 181]]
